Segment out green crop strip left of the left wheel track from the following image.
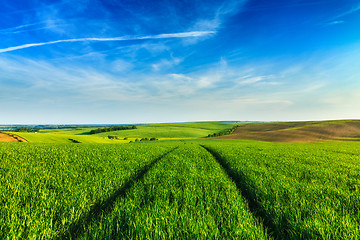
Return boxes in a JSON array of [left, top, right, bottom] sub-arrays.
[[0, 143, 176, 239]]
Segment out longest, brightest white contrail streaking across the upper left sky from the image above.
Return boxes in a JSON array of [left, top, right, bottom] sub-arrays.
[[0, 31, 215, 53]]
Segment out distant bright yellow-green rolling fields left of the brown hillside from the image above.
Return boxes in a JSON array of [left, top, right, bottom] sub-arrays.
[[7, 122, 235, 143]]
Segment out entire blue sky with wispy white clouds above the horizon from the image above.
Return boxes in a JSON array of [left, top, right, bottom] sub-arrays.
[[0, 0, 360, 124]]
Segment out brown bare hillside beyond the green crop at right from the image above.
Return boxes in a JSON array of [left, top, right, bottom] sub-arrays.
[[217, 120, 360, 142]]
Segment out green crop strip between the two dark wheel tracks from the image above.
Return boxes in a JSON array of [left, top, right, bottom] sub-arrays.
[[80, 144, 268, 239]]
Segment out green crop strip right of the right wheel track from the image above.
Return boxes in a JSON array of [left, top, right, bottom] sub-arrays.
[[204, 143, 360, 239]]
